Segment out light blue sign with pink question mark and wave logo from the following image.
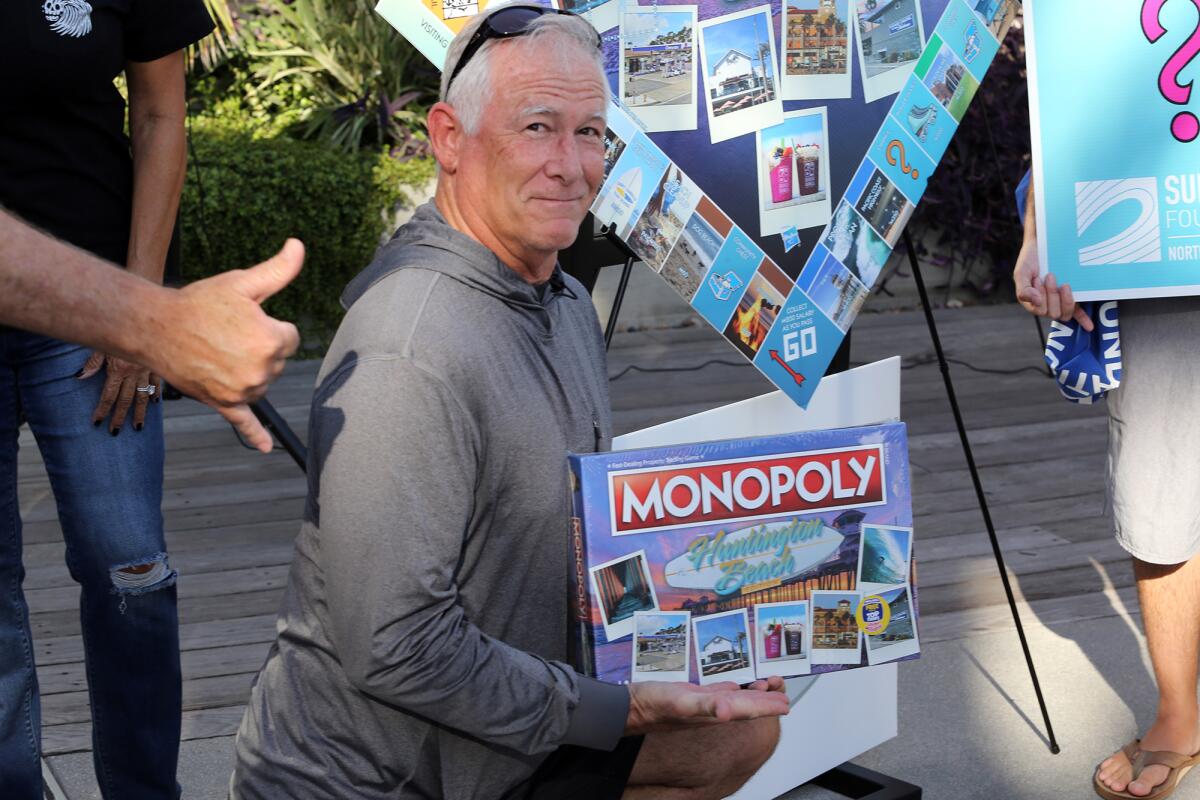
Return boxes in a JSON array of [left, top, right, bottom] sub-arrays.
[[1025, 0, 1200, 300]]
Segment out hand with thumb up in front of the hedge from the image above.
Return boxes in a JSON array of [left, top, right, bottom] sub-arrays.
[[148, 239, 304, 452]]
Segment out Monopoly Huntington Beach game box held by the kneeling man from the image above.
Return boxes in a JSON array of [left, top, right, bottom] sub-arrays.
[[569, 422, 920, 684]]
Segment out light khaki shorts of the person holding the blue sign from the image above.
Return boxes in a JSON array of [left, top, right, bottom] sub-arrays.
[[1106, 297, 1200, 564]]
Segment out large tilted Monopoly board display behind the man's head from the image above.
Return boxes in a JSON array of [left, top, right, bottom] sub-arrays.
[[378, 0, 1020, 407]]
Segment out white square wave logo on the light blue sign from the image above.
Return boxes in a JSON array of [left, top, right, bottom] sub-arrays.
[[1075, 178, 1163, 266]]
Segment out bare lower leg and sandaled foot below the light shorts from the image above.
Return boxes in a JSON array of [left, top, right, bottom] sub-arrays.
[[1100, 557, 1200, 796]]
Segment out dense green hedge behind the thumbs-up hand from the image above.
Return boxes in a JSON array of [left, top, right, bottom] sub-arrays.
[[180, 118, 433, 350]]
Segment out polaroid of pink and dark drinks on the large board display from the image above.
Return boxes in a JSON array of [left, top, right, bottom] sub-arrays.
[[755, 106, 833, 236]]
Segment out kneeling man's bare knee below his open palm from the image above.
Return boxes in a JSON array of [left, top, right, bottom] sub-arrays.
[[623, 718, 779, 800]]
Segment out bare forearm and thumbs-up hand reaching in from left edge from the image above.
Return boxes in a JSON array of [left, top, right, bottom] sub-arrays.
[[0, 210, 304, 452]]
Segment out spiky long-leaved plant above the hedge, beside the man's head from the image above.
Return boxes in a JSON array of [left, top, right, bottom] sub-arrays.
[[245, 0, 437, 158]]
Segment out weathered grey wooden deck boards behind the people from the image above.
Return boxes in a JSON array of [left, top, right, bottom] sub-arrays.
[[20, 307, 1108, 756]]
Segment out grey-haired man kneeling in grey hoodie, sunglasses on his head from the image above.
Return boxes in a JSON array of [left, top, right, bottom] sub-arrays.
[[230, 6, 788, 800]]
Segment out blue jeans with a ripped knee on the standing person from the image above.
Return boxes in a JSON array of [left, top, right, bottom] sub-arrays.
[[0, 327, 181, 800]]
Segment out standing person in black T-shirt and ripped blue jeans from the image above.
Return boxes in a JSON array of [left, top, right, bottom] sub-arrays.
[[0, 0, 212, 800]]
